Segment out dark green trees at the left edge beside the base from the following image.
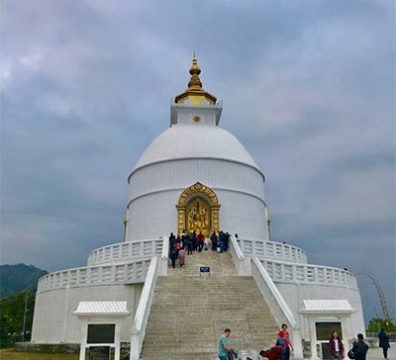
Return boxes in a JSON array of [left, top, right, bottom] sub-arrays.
[[0, 291, 35, 348]]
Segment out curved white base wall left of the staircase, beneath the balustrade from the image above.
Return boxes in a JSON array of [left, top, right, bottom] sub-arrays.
[[32, 284, 143, 344]]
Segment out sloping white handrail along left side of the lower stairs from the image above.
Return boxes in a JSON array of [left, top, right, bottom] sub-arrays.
[[130, 256, 159, 360]]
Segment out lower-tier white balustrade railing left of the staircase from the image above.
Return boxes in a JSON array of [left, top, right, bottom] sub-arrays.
[[37, 259, 150, 293]]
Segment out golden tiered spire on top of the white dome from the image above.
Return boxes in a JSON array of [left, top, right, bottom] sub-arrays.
[[175, 56, 217, 105]]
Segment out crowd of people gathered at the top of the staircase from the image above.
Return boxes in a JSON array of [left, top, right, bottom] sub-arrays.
[[169, 230, 230, 268]]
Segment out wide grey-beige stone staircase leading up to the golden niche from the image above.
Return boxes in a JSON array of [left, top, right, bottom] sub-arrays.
[[141, 251, 277, 360]]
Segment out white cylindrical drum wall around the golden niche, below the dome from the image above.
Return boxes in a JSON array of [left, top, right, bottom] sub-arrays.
[[127, 159, 268, 240]]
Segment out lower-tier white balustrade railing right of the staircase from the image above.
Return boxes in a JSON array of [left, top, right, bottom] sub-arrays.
[[259, 259, 358, 290]]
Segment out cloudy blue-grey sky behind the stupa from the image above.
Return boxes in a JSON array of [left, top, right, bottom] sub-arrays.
[[0, 0, 396, 318]]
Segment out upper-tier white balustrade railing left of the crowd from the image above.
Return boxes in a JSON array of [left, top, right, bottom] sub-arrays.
[[88, 237, 163, 265]]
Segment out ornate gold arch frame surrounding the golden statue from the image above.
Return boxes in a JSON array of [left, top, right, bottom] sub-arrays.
[[176, 181, 221, 234]]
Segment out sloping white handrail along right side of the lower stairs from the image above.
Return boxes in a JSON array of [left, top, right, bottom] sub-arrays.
[[252, 257, 297, 328]]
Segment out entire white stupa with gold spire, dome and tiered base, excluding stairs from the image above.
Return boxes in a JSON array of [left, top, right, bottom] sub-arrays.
[[32, 58, 364, 358]]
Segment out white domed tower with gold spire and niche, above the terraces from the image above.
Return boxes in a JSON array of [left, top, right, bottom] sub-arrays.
[[126, 58, 269, 241]]
